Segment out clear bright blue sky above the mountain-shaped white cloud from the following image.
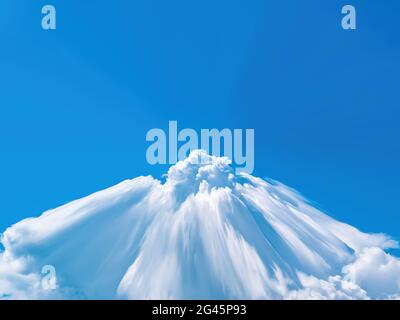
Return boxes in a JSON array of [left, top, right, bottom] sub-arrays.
[[0, 0, 400, 239]]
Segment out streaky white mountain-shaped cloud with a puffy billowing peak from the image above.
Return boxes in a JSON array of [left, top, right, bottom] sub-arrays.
[[0, 151, 400, 299]]
